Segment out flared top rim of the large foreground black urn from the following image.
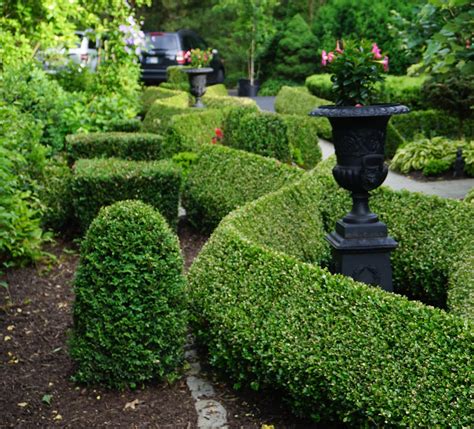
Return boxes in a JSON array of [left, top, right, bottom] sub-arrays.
[[309, 104, 410, 118]]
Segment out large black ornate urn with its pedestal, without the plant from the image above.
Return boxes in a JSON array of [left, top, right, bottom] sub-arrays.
[[310, 104, 409, 291]]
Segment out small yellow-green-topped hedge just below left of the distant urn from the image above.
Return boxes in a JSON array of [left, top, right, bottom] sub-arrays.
[[142, 92, 193, 134]]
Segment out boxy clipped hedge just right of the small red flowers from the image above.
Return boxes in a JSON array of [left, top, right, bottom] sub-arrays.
[[223, 109, 321, 168]]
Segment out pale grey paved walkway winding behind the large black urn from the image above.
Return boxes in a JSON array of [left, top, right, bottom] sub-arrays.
[[252, 97, 474, 199]]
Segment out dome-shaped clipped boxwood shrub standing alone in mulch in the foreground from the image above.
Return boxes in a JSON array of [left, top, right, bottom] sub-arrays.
[[69, 201, 187, 388]]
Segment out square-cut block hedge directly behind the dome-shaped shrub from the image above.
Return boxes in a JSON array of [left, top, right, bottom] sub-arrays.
[[71, 158, 181, 231]]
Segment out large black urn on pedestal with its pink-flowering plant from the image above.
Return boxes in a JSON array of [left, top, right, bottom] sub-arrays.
[[311, 42, 408, 291]]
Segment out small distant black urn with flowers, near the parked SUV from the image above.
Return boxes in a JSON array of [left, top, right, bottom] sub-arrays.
[[182, 48, 213, 108]]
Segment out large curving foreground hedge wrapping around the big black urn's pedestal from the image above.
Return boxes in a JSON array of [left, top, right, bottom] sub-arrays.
[[188, 165, 474, 427]]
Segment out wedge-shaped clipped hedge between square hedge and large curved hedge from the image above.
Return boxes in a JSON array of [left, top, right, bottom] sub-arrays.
[[182, 145, 303, 230]]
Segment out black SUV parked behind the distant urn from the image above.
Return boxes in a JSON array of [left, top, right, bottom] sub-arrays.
[[141, 30, 225, 84]]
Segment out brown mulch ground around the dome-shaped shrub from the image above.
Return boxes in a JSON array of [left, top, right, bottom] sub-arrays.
[[0, 219, 327, 429]]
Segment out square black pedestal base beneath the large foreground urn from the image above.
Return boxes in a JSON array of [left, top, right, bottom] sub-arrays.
[[326, 220, 397, 292]]
